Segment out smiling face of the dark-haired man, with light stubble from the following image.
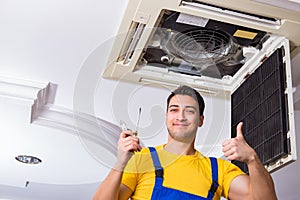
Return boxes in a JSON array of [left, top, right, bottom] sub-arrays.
[[166, 95, 203, 142]]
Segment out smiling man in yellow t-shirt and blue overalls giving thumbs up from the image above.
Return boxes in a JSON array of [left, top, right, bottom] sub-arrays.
[[94, 86, 277, 200]]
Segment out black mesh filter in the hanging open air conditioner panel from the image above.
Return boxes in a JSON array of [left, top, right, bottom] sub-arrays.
[[231, 49, 289, 172]]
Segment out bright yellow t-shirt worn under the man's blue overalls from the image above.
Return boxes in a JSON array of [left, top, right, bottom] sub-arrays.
[[122, 145, 244, 200]]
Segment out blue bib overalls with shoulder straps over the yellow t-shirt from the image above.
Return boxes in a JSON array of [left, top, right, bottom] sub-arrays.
[[149, 147, 219, 200]]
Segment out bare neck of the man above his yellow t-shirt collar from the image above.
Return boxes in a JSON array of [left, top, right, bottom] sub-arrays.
[[164, 139, 196, 155]]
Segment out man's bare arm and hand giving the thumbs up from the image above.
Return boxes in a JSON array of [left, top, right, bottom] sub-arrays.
[[222, 122, 277, 200]]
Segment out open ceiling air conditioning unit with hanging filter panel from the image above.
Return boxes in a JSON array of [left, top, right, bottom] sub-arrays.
[[103, 0, 300, 171]]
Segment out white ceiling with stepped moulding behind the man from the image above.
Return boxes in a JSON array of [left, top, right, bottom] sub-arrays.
[[0, 0, 300, 200]]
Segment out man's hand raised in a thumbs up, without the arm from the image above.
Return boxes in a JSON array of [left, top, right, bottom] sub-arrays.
[[222, 122, 256, 164]]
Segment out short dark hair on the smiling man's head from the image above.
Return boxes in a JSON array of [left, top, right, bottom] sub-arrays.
[[167, 85, 205, 116]]
